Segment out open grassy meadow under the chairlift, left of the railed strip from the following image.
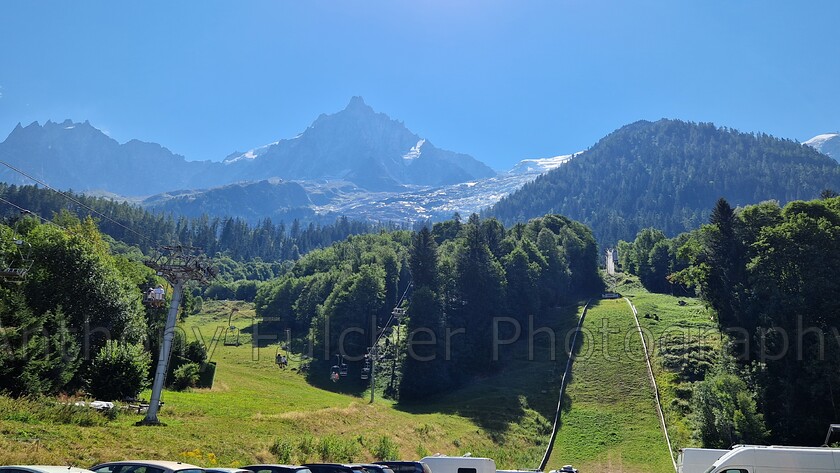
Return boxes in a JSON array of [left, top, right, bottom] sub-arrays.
[[0, 302, 578, 468]]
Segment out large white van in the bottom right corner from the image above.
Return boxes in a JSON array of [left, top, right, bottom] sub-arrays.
[[706, 446, 840, 473]]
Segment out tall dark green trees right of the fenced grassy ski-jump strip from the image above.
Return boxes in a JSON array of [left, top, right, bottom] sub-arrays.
[[619, 193, 840, 448]]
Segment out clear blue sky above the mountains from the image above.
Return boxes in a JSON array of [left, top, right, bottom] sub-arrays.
[[0, 0, 840, 169]]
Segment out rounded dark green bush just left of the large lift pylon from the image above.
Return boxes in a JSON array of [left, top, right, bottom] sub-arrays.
[[85, 340, 151, 401]]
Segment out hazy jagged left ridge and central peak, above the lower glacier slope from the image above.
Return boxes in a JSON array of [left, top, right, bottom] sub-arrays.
[[0, 97, 496, 196]]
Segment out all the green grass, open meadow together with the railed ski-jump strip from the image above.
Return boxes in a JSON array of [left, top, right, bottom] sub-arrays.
[[0, 279, 713, 472]]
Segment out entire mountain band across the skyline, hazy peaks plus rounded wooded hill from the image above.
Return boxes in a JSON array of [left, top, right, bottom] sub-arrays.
[[0, 97, 840, 240]]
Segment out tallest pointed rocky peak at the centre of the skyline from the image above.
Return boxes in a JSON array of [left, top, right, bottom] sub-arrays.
[[225, 97, 496, 190]]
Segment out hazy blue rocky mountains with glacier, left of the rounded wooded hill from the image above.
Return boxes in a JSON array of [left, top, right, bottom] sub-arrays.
[[0, 97, 569, 221]]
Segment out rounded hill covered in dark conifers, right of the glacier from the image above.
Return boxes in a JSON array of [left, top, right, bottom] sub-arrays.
[[489, 120, 840, 244]]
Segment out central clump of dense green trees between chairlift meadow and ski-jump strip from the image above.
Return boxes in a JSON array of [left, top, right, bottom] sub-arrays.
[[255, 215, 602, 396]]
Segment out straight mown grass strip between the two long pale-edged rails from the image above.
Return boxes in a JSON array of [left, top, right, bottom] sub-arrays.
[[548, 299, 673, 473]]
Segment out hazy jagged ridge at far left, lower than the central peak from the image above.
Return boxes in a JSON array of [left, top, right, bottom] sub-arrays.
[[0, 120, 225, 195]]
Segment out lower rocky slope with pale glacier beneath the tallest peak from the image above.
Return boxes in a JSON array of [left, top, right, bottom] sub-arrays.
[[142, 155, 572, 223]]
